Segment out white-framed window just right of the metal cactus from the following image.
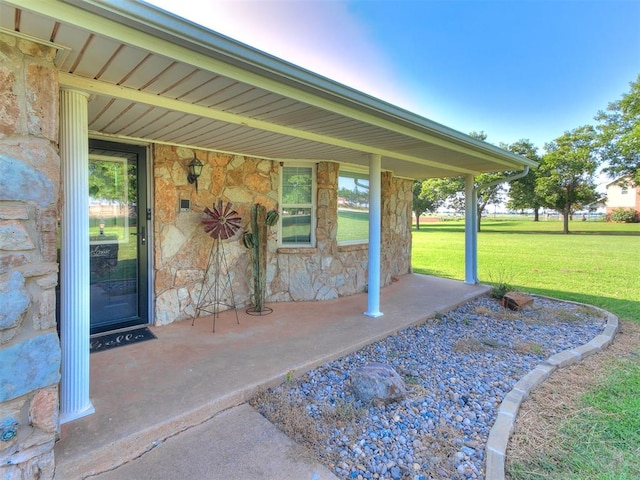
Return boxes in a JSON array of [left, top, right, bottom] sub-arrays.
[[280, 165, 316, 247]]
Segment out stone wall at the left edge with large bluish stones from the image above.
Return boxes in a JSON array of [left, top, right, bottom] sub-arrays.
[[0, 33, 60, 480]]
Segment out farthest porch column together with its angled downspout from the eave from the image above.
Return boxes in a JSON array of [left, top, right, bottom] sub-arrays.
[[464, 165, 529, 285]]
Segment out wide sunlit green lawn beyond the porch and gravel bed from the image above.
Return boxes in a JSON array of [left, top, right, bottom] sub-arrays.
[[412, 219, 640, 322]]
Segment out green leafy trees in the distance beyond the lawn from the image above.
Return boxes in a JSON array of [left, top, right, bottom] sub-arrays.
[[413, 75, 640, 233]]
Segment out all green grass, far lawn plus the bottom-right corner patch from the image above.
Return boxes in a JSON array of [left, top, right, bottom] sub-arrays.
[[412, 218, 640, 480]]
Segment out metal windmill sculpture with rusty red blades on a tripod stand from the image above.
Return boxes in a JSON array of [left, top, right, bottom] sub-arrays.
[[191, 200, 241, 332]]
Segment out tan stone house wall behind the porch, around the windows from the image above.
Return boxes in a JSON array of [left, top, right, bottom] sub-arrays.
[[153, 145, 413, 325]]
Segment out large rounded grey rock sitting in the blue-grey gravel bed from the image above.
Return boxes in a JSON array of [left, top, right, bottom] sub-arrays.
[[351, 363, 407, 403]]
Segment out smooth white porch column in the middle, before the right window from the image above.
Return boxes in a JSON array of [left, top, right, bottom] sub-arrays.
[[364, 154, 383, 317]]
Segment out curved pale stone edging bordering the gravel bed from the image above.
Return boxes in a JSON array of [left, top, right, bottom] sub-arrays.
[[485, 295, 619, 480]]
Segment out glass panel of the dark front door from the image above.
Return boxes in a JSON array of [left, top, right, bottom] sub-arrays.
[[89, 151, 139, 333]]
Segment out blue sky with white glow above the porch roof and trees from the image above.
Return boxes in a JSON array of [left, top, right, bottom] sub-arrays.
[[146, 0, 640, 152]]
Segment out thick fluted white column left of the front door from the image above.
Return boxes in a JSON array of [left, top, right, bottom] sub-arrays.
[[60, 89, 95, 423]]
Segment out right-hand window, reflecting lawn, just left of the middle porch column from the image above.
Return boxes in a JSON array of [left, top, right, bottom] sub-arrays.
[[338, 170, 369, 245]]
